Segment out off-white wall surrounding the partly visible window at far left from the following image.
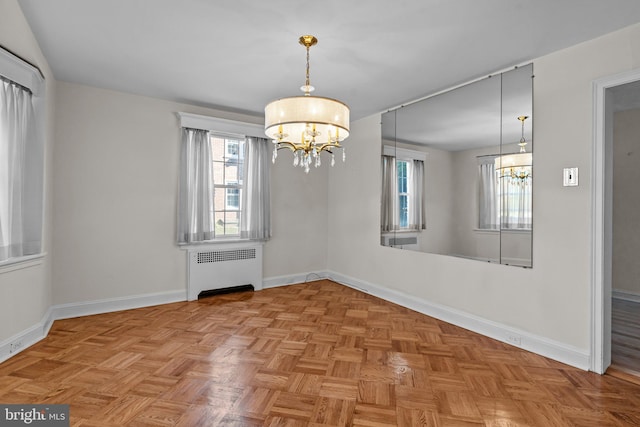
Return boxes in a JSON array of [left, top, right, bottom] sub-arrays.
[[0, 0, 55, 346]]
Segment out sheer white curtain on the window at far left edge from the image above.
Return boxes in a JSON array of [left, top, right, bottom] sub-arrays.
[[0, 78, 42, 262]]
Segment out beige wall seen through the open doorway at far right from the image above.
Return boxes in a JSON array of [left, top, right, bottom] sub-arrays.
[[612, 110, 640, 296]]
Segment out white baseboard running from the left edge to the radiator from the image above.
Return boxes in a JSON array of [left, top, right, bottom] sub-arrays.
[[0, 290, 187, 363]]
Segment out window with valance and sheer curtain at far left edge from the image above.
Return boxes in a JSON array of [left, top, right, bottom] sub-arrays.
[[0, 49, 44, 265]]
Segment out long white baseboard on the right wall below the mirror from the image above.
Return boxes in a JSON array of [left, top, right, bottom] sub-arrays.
[[327, 271, 591, 371]]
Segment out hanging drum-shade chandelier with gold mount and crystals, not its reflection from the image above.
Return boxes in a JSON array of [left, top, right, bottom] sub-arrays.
[[264, 35, 349, 173]]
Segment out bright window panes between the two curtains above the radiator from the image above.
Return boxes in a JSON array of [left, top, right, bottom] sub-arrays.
[[210, 134, 245, 238]]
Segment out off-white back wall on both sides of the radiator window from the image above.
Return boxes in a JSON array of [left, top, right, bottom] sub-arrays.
[[53, 82, 327, 304]]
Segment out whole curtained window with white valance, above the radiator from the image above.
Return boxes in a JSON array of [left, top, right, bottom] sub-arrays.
[[176, 113, 271, 245]]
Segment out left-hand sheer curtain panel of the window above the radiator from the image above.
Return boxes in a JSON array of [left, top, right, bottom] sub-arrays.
[[178, 128, 215, 243]]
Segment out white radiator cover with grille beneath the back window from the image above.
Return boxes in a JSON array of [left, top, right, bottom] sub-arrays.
[[187, 244, 262, 301]]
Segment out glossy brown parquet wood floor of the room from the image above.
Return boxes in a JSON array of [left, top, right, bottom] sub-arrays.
[[0, 280, 640, 427]]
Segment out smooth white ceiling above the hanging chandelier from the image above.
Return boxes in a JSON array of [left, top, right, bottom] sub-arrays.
[[19, 0, 640, 120]]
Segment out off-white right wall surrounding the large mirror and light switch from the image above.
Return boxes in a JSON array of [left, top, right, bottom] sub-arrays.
[[328, 21, 640, 353]]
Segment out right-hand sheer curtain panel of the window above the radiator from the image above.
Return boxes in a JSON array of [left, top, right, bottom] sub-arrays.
[[240, 137, 271, 240]]
